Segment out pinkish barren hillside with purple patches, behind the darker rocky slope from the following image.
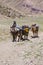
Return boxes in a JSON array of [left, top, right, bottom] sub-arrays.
[[0, 0, 43, 14]]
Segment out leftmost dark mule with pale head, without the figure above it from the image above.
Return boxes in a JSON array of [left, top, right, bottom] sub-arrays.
[[10, 27, 22, 42]]
